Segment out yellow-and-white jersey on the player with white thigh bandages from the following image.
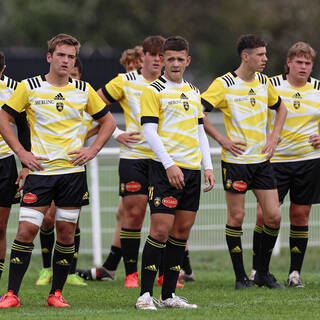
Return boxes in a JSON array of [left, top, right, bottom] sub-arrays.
[[3, 75, 109, 175]]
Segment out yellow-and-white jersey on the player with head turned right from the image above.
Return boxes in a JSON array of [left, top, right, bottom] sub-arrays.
[[201, 72, 281, 164]]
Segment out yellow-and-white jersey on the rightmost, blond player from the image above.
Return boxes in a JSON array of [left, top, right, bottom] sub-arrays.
[[269, 75, 320, 162]]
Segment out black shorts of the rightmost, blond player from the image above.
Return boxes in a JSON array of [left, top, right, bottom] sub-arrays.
[[272, 159, 320, 205]]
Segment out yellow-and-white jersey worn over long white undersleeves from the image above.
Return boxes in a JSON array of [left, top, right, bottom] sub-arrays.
[[141, 76, 203, 170]]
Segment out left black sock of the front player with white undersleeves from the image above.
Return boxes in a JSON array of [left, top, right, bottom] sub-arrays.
[[140, 235, 166, 296]]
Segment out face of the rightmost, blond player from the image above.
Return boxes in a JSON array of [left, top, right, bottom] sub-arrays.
[[287, 56, 313, 81]]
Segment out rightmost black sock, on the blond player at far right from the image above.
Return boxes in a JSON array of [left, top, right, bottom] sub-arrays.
[[289, 225, 309, 274]]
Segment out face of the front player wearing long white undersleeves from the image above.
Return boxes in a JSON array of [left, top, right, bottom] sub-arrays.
[[163, 50, 191, 83]]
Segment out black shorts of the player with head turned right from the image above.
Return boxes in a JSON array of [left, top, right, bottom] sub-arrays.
[[221, 161, 277, 193]]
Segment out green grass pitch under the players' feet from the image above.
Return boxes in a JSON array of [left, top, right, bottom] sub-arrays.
[[0, 248, 320, 320]]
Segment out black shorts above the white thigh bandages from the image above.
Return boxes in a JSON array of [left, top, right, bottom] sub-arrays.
[[21, 172, 89, 207]]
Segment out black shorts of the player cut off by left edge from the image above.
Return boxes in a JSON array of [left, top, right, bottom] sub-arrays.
[[0, 155, 20, 208]]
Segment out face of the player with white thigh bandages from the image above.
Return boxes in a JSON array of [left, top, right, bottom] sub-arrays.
[[47, 44, 77, 77]]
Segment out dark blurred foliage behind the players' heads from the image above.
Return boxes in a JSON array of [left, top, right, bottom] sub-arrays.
[[0, 0, 320, 89]]
